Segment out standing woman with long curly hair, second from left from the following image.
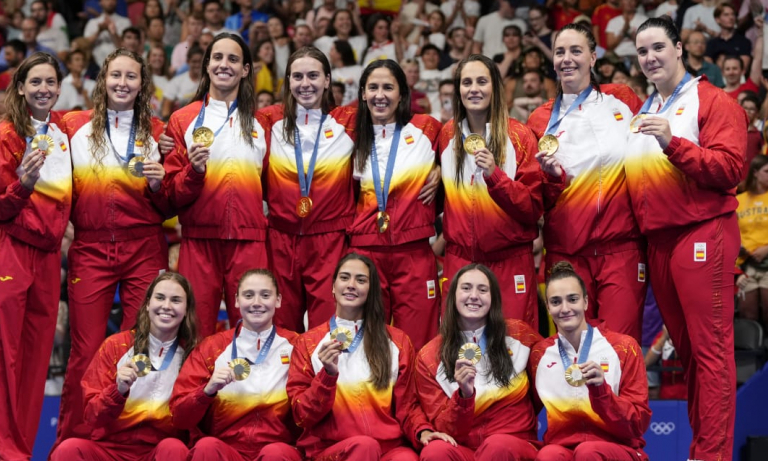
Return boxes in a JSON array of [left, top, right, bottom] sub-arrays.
[[57, 48, 173, 443]]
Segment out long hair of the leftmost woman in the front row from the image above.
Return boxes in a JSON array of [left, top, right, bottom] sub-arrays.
[[133, 272, 200, 359]]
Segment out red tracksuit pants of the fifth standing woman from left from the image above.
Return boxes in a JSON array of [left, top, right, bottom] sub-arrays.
[[350, 240, 440, 351]]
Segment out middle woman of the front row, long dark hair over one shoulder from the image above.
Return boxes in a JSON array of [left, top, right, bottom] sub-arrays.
[[288, 253, 453, 461]]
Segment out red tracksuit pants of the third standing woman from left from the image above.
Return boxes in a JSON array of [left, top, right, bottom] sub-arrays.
[[179, 238, 268, 338]]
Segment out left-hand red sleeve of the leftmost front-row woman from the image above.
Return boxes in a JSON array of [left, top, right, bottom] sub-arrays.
[[81, 333, 133, 427]]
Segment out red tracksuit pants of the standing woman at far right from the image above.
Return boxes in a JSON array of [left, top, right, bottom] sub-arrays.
[[648, 213, 740, 461]]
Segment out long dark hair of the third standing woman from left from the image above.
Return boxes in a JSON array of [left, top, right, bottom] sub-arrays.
[[192, 33, 256, 146]]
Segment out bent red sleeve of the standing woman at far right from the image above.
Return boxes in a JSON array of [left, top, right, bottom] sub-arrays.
[[664, 81, 748, 190]]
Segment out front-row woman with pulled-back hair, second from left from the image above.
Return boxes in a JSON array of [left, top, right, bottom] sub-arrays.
[[171, 269, 302, 461]]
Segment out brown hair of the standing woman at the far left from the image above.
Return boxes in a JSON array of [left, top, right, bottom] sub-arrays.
[[4, 51, 62, 138]]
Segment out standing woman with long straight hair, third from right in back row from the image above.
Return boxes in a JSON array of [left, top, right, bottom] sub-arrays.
[[439, 54, 542, 329]]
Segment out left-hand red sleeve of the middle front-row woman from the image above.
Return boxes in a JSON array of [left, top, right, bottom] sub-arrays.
[[285, 334, 339, 429]]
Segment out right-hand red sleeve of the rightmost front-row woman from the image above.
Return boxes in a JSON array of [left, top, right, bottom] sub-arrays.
[[588, 335, 651, 440]]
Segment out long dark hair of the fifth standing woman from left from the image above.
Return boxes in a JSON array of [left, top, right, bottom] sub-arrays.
[[355, 59, 413, 171]]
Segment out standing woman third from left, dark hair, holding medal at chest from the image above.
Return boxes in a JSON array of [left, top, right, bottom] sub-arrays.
[[166, 34, 267, 337]]
